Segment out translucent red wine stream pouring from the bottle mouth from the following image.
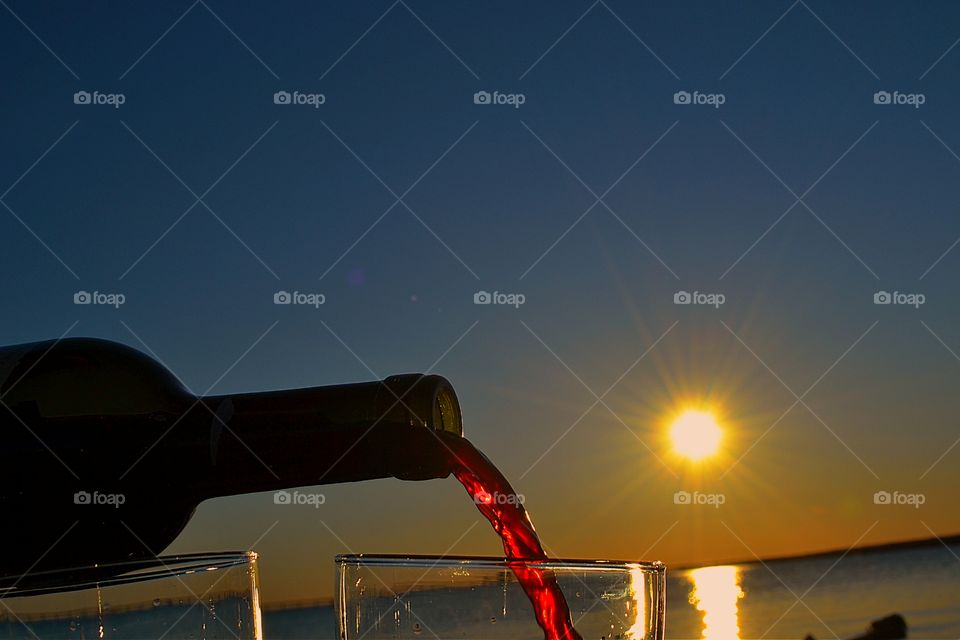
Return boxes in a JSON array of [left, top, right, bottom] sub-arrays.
[[443, 437, 581, 640]]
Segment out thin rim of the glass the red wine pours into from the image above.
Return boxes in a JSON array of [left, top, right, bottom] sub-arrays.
[[334, 553, 667, 576]]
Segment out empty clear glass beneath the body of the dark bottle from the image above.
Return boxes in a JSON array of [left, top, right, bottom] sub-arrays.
[[0, 552, 262, 640]]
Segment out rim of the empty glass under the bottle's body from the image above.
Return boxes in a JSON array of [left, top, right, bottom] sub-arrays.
[[0, 551, 257, 599]]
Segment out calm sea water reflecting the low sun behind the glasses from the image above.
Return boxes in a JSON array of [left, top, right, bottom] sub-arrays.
[[263, 539, 960, 640]]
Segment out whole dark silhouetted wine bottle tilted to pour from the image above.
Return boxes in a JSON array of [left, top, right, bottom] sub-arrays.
[[0, 338, 462, 586]]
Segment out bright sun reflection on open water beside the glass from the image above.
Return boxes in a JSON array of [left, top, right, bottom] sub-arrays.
[[689, 566, 744, 640]]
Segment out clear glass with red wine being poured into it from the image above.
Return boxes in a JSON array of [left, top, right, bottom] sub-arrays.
[[335, 554, 665, 640]]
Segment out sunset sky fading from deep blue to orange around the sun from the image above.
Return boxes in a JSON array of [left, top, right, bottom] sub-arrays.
[[0, 0, 960, 604]]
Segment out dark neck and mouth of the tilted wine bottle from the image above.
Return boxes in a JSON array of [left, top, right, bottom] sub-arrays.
[[190, 376, 462, 497]]
